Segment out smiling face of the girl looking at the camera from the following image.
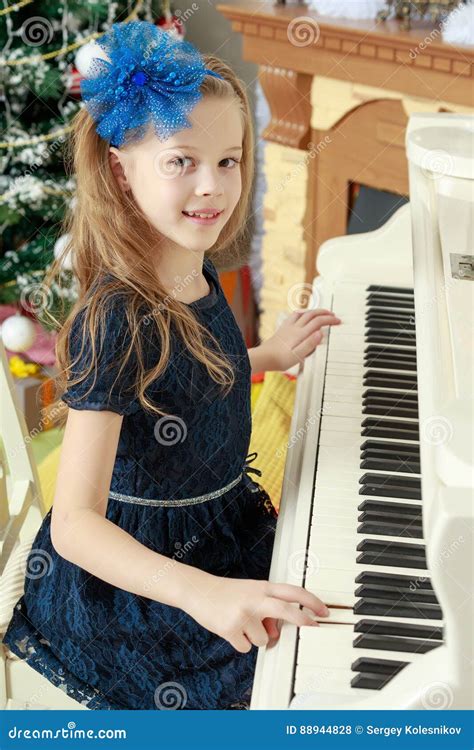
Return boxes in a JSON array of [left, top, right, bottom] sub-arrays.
[[110, 96, 243, 252]]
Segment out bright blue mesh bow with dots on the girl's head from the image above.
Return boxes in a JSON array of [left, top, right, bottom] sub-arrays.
[[81, 21, 222, 146]]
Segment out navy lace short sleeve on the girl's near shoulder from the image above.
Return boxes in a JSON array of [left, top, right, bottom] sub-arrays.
[[61, 299, 140, 415]]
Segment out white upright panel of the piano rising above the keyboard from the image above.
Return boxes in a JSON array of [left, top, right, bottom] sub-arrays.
[[406, 113, 474, 494]]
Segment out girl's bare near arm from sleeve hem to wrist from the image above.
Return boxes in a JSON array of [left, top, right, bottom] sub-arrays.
[[51, 409, 213, 609]]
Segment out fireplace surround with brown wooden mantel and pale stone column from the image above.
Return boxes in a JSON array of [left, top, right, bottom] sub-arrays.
[[217, 0, 474, 339]]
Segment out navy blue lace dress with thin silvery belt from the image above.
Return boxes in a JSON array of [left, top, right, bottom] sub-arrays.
[[3, 259, 277, 710]]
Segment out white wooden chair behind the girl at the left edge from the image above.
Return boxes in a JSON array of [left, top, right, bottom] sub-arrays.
[[0, 337, 87, 710]]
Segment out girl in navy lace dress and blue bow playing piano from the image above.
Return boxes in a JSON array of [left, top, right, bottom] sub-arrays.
[[0, 22, 338, 710]]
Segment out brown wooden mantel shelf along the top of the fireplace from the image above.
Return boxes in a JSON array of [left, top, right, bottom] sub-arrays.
[[216, 2, 474, 107]]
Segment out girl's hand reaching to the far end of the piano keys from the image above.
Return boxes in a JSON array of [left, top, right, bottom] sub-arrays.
[[260, 309, 341, 370]]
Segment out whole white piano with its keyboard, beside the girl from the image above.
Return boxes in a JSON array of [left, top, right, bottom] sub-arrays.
[[251, 113, 474, 709]]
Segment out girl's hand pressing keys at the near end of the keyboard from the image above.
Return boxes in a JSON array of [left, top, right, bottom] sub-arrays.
[[184, 574, 329, 653]]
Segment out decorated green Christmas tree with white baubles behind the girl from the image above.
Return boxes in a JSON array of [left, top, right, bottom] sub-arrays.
[[0, 0, 184, 330]]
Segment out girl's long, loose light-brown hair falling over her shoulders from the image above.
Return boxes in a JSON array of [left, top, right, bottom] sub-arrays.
[[44, 55, 254, 424]]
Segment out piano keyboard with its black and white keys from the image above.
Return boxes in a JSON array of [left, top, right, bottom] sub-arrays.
[[293, 283, 443, 707]]
